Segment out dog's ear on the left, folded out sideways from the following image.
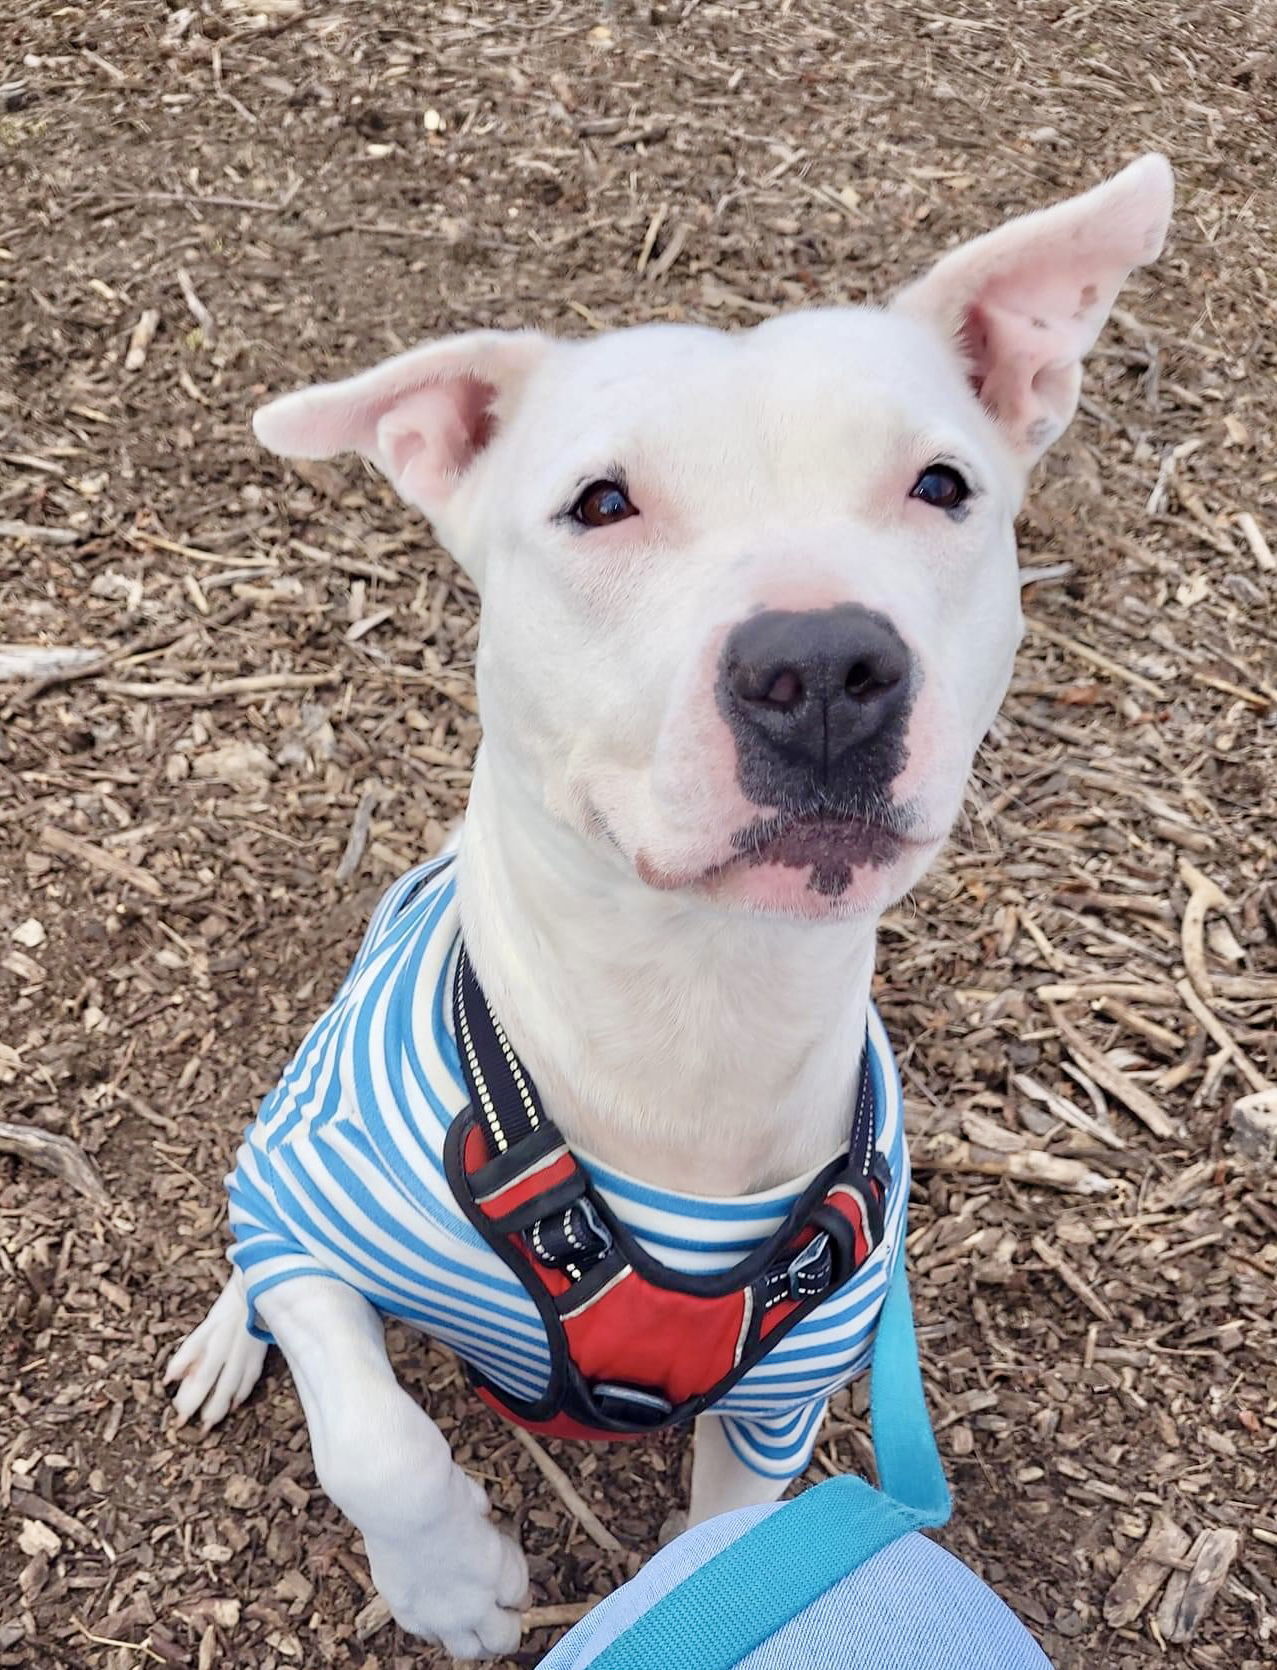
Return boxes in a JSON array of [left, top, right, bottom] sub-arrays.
[[252, 331, 551, 519]]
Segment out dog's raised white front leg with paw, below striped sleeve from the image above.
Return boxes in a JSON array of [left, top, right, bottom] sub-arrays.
[[259, 1276, 527, 1658]]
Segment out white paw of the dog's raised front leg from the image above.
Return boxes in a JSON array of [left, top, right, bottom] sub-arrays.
[[366, 1511, 527, 1658]]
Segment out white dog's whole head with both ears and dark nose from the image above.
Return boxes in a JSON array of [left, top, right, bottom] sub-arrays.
[[255, 155, 1172, 917]]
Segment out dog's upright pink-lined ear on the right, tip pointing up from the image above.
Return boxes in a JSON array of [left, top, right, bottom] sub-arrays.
[[893, 152, 1174, 464]]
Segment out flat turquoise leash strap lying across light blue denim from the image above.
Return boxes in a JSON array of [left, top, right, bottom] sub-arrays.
[[589, 1234, 950, 1670]]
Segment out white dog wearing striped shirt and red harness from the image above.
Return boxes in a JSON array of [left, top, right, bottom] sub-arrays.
[[170, 155, 1172, 1655]]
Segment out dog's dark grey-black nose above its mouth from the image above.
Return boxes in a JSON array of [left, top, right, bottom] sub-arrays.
[[719, 603, 911, 802]]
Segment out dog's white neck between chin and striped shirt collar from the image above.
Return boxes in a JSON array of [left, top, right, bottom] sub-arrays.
[[459, 746, 875, 1196]]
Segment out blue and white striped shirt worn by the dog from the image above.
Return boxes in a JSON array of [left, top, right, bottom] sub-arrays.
[[227, 860, 908, 1478]]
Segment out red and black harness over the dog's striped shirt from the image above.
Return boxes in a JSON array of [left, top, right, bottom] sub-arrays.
[[444, 947, 890, 1438]]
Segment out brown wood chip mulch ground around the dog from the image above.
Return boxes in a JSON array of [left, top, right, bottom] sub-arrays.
[[0, 0, 1277, 1670]]
